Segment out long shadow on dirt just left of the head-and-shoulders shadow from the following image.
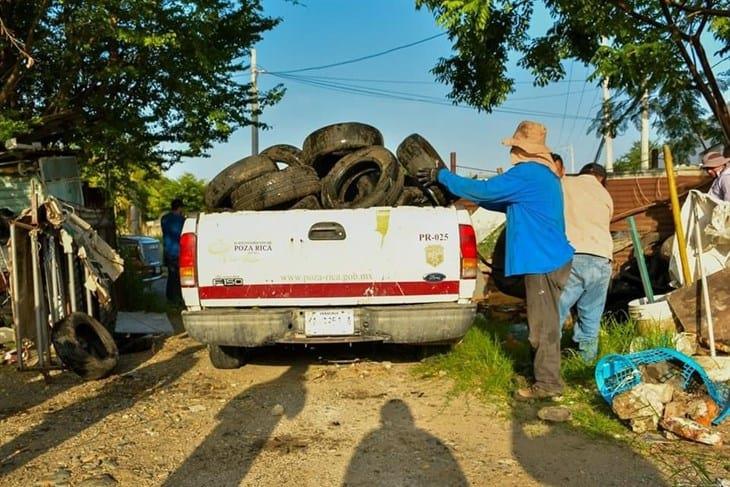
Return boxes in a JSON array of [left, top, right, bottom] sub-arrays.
[[164, 363, 308, 487]]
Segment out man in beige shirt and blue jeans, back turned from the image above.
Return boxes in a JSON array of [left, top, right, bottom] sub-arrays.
[[560, 164, 613, 363]]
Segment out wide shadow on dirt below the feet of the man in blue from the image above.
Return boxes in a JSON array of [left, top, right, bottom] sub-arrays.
[[512, 402, 667, 487]]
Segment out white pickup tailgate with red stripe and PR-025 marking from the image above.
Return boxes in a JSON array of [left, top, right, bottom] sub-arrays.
[[196, 207, 466, 307]]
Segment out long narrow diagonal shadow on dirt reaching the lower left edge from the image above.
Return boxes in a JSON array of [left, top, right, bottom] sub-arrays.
[[0, 346, 202, 478]]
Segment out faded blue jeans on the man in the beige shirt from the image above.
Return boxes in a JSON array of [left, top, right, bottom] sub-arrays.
[[560, 254, 611, 362]]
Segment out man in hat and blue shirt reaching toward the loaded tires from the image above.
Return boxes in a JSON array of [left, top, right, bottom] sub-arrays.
[[418, 121, 573, 400]]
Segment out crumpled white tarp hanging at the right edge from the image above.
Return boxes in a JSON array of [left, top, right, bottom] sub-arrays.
[[669, 190, 730, 287]]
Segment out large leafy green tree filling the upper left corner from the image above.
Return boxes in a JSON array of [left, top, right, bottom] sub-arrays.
[[0, 0, 282, 191]]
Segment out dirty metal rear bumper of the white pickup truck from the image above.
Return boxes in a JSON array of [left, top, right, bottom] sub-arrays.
[[182, 303, 476, 347]]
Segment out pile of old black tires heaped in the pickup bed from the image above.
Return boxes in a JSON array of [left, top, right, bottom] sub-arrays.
[[205, 122, 451, 210]]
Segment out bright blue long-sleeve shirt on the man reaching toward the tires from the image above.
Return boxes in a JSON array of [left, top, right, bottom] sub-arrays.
[[438, 162, 574, 276]]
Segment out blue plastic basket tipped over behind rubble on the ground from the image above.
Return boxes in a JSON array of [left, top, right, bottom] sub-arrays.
[[596, 348, 730, 425]]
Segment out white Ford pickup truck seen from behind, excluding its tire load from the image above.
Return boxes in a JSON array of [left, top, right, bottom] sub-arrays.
[[180, 206, 477, 368]]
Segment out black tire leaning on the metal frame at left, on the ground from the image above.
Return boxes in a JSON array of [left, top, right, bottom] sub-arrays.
[[51, 312, 119, 380]]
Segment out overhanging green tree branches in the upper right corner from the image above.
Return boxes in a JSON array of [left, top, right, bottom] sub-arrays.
[[416, 0, 730, 151]]
